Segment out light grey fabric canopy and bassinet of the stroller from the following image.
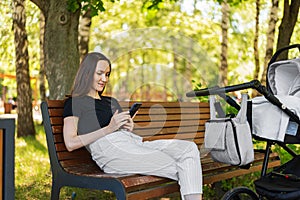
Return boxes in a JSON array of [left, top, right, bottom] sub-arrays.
[[252, 58, 300, 141]]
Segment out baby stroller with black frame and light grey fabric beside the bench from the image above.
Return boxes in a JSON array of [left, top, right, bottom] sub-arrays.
[[186, 44, 300, 200]]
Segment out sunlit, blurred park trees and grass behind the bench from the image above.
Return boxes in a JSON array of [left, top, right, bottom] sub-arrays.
[[0, 0, 300, 199]]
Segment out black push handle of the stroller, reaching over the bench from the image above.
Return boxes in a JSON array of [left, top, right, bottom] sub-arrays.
[[186, 80, 300, 125]]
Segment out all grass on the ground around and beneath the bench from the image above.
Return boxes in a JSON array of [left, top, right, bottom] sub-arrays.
[[15, 124, 299, 200]]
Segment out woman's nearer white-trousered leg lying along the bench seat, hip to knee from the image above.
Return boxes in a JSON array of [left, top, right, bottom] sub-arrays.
[[89, 134, 178, 180]]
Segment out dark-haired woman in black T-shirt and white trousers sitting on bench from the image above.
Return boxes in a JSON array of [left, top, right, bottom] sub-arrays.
[[63, 53, 202, 200]]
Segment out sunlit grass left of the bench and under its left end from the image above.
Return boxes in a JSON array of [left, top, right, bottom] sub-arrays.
[[15, 125, 115, 200]]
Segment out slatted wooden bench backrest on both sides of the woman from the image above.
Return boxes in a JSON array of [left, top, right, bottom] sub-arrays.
[[42, 100, 209, 170]]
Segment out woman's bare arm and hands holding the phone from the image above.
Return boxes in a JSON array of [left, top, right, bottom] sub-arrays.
[[63, 111, 133, 151]]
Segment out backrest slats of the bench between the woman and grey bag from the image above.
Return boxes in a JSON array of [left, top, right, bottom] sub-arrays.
[[120, 102, 209, 145]]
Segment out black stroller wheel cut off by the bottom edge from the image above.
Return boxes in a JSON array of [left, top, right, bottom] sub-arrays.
[[222, 187, 258, 200]]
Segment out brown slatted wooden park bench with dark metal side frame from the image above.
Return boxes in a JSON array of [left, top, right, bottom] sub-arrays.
[[41, 100, 280, 200]]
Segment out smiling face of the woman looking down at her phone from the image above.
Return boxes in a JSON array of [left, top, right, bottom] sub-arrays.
[[91, 60, 110, 92]]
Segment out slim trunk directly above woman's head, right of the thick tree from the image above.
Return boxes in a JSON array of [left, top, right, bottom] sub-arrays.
[[79, 9, 92, 61]]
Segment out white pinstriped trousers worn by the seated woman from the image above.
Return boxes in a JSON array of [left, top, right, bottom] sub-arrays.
[[89, 131, 202, 197]]
